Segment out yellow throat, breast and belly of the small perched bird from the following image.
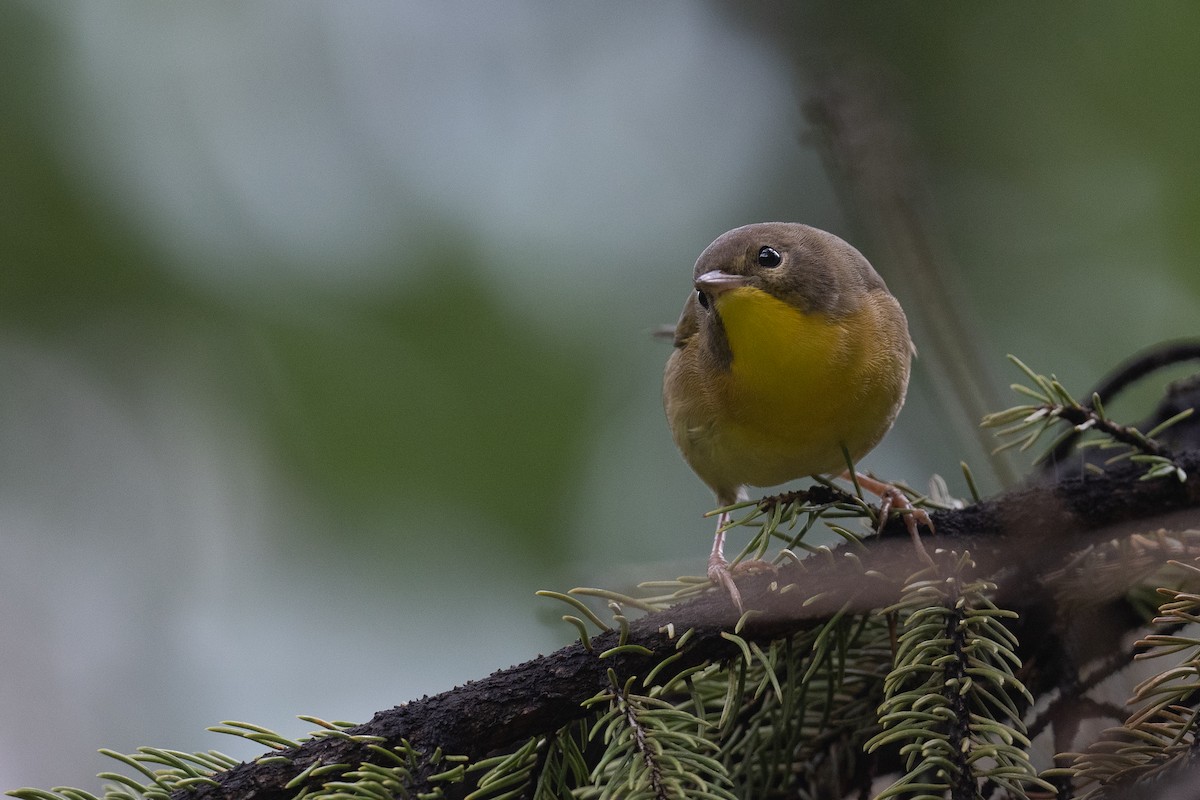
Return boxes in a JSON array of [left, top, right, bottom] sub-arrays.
[[672, 287, 911, 497]]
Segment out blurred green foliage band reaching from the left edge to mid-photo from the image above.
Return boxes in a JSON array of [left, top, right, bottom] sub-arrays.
[[0, 6, 596, 559]]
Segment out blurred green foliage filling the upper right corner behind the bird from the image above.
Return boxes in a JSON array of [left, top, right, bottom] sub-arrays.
[[791, 0, 1200, 347]]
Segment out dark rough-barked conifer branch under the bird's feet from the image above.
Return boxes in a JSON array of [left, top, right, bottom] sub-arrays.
[[175, 452, 1200, 800]]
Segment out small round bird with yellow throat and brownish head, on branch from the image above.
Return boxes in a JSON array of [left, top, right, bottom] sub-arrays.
[[662, 222, 929, 609]]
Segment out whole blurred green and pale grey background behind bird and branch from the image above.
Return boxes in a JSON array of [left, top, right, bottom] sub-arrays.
[[0, 0, 1200, 789]]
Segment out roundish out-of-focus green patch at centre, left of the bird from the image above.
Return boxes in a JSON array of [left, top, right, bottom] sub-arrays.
[[259, 263, 595, 554]]
